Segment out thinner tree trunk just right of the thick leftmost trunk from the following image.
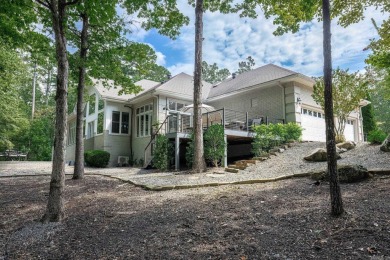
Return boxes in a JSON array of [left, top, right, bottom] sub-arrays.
[[73, 13, 89, 179]]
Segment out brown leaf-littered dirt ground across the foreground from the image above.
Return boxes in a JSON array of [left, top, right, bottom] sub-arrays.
[[0, 176, 390, 260]]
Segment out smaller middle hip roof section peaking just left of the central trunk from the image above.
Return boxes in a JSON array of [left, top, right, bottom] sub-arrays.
[[130, 72, 212, 102]]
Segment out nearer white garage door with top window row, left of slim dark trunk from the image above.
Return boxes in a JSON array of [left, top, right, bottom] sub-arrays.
[[301, 109, 326, 142]]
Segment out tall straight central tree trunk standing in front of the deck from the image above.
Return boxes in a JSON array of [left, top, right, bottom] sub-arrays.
[[192, 0, 206, 173]]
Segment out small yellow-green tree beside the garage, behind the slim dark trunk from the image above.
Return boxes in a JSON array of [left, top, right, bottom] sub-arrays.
[[312, 69, 368, 139]]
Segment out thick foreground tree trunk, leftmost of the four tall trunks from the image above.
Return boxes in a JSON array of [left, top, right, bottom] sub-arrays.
[[42, 0, 69, 223]]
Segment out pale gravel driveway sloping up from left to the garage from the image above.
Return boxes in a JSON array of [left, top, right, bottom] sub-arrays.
[[0, 142, 390, 188]]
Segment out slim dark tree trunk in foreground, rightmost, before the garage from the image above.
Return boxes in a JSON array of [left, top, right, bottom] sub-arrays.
[[322, 0, 344, 216]]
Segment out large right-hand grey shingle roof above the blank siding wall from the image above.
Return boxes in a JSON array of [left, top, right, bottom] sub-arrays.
[[208, 64, 313, 98]]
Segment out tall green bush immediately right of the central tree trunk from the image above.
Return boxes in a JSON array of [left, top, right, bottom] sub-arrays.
[[203, 125, 226, 167]]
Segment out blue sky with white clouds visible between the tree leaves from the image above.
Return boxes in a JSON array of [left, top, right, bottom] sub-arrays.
[[127, 0, 386, 76]]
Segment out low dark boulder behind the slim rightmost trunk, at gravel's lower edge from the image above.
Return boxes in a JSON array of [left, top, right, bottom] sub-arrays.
[[310, 165, 369, 183]]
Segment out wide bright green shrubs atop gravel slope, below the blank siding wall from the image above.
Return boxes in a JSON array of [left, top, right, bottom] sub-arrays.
[[252, 123, 302, 156]]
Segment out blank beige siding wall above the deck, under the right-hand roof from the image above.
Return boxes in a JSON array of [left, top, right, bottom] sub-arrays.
[[207, 86, 284, 122]]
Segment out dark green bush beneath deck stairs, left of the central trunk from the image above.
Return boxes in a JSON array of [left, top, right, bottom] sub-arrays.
[[153, 135, 174, 171]]
